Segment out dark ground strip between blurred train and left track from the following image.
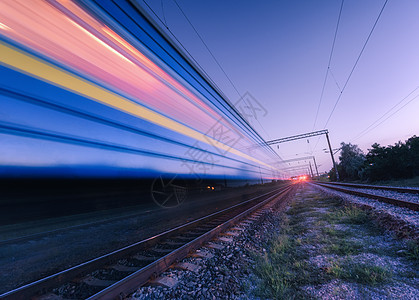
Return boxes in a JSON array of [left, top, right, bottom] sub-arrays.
[[0, 184, 278, 294]]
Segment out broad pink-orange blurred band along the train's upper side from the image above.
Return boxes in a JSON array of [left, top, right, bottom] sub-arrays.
[[0, 0, 225, 135]]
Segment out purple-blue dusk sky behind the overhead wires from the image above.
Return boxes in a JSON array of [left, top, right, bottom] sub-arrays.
[[143, 0, 419, 176]]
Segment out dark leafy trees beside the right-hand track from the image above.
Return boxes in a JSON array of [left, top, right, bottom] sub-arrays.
[[329, 135, 419, 181]]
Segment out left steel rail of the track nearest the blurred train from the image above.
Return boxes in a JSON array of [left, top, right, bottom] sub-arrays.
[[0, 185, 292, 300]]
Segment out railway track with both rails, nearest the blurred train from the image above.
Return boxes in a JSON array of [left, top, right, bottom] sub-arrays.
[[0, 185, 292, 299]]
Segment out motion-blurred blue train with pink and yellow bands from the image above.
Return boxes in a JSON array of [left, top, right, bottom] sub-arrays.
[[0, 0, 280, 181]]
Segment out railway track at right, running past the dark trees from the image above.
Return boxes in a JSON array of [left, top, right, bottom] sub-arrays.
[[313, 182, 419, 211]]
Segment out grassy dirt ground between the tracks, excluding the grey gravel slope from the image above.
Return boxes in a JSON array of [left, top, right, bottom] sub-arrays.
[[246, 185, 419, 299]]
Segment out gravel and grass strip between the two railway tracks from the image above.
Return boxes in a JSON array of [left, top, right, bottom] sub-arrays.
[[130, 185, 419, 299]]
